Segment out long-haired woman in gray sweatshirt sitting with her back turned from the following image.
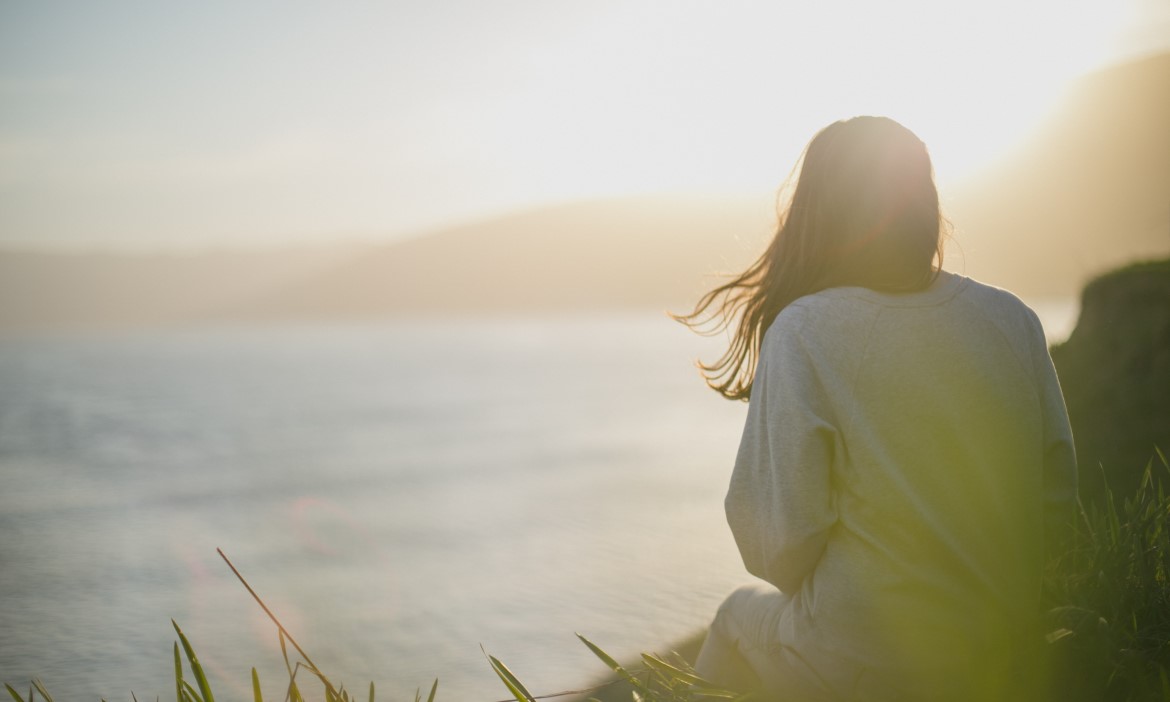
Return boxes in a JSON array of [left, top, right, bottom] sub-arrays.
[[681, 117, 1076, 701]]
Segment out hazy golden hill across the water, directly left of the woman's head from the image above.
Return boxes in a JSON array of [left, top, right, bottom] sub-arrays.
[[225, 198, 775, 317]]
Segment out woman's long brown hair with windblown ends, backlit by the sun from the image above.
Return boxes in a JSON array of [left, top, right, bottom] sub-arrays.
[[675, 117, 945, 400]]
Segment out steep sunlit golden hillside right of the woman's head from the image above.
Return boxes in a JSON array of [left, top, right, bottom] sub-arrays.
[[950, 54, 1170, 296]]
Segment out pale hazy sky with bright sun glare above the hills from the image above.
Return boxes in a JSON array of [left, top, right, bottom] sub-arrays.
[[0, 0, 1170, 252]]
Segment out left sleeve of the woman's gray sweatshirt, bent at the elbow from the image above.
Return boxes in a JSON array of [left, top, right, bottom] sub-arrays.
[[724, 316, 837, 593]]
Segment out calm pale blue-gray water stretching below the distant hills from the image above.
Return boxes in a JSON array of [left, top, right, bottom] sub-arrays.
[[0, 304, 1072, 701]]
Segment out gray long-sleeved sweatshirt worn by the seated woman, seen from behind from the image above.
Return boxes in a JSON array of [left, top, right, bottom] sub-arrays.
[[725, 273, 1076, 700]]
